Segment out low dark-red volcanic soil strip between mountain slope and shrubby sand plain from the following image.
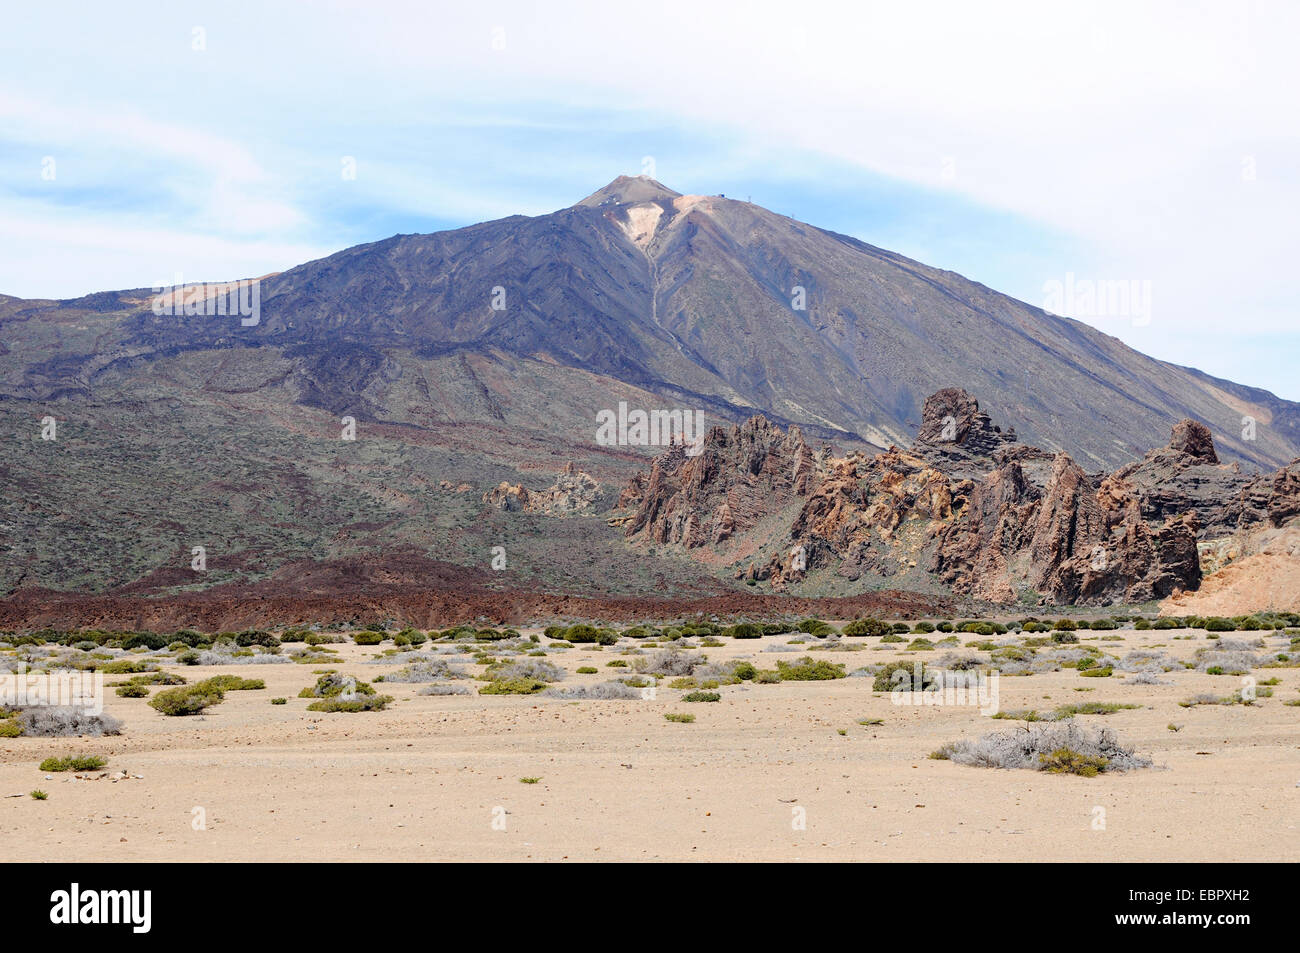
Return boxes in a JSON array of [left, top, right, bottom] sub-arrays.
[[0, 554, 953, 632]]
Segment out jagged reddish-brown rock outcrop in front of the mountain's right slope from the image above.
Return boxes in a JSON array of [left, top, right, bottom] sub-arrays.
[[620, 389, 1274, 605]]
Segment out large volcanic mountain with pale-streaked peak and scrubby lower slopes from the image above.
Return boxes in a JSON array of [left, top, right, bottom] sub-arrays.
[[0, 177, 1300, 593]]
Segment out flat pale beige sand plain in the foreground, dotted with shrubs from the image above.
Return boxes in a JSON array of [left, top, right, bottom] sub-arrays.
[[0, 632, 1300, 861]]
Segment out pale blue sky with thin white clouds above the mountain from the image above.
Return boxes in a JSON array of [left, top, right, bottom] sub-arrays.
[[0, 0, 1300, 400]]
